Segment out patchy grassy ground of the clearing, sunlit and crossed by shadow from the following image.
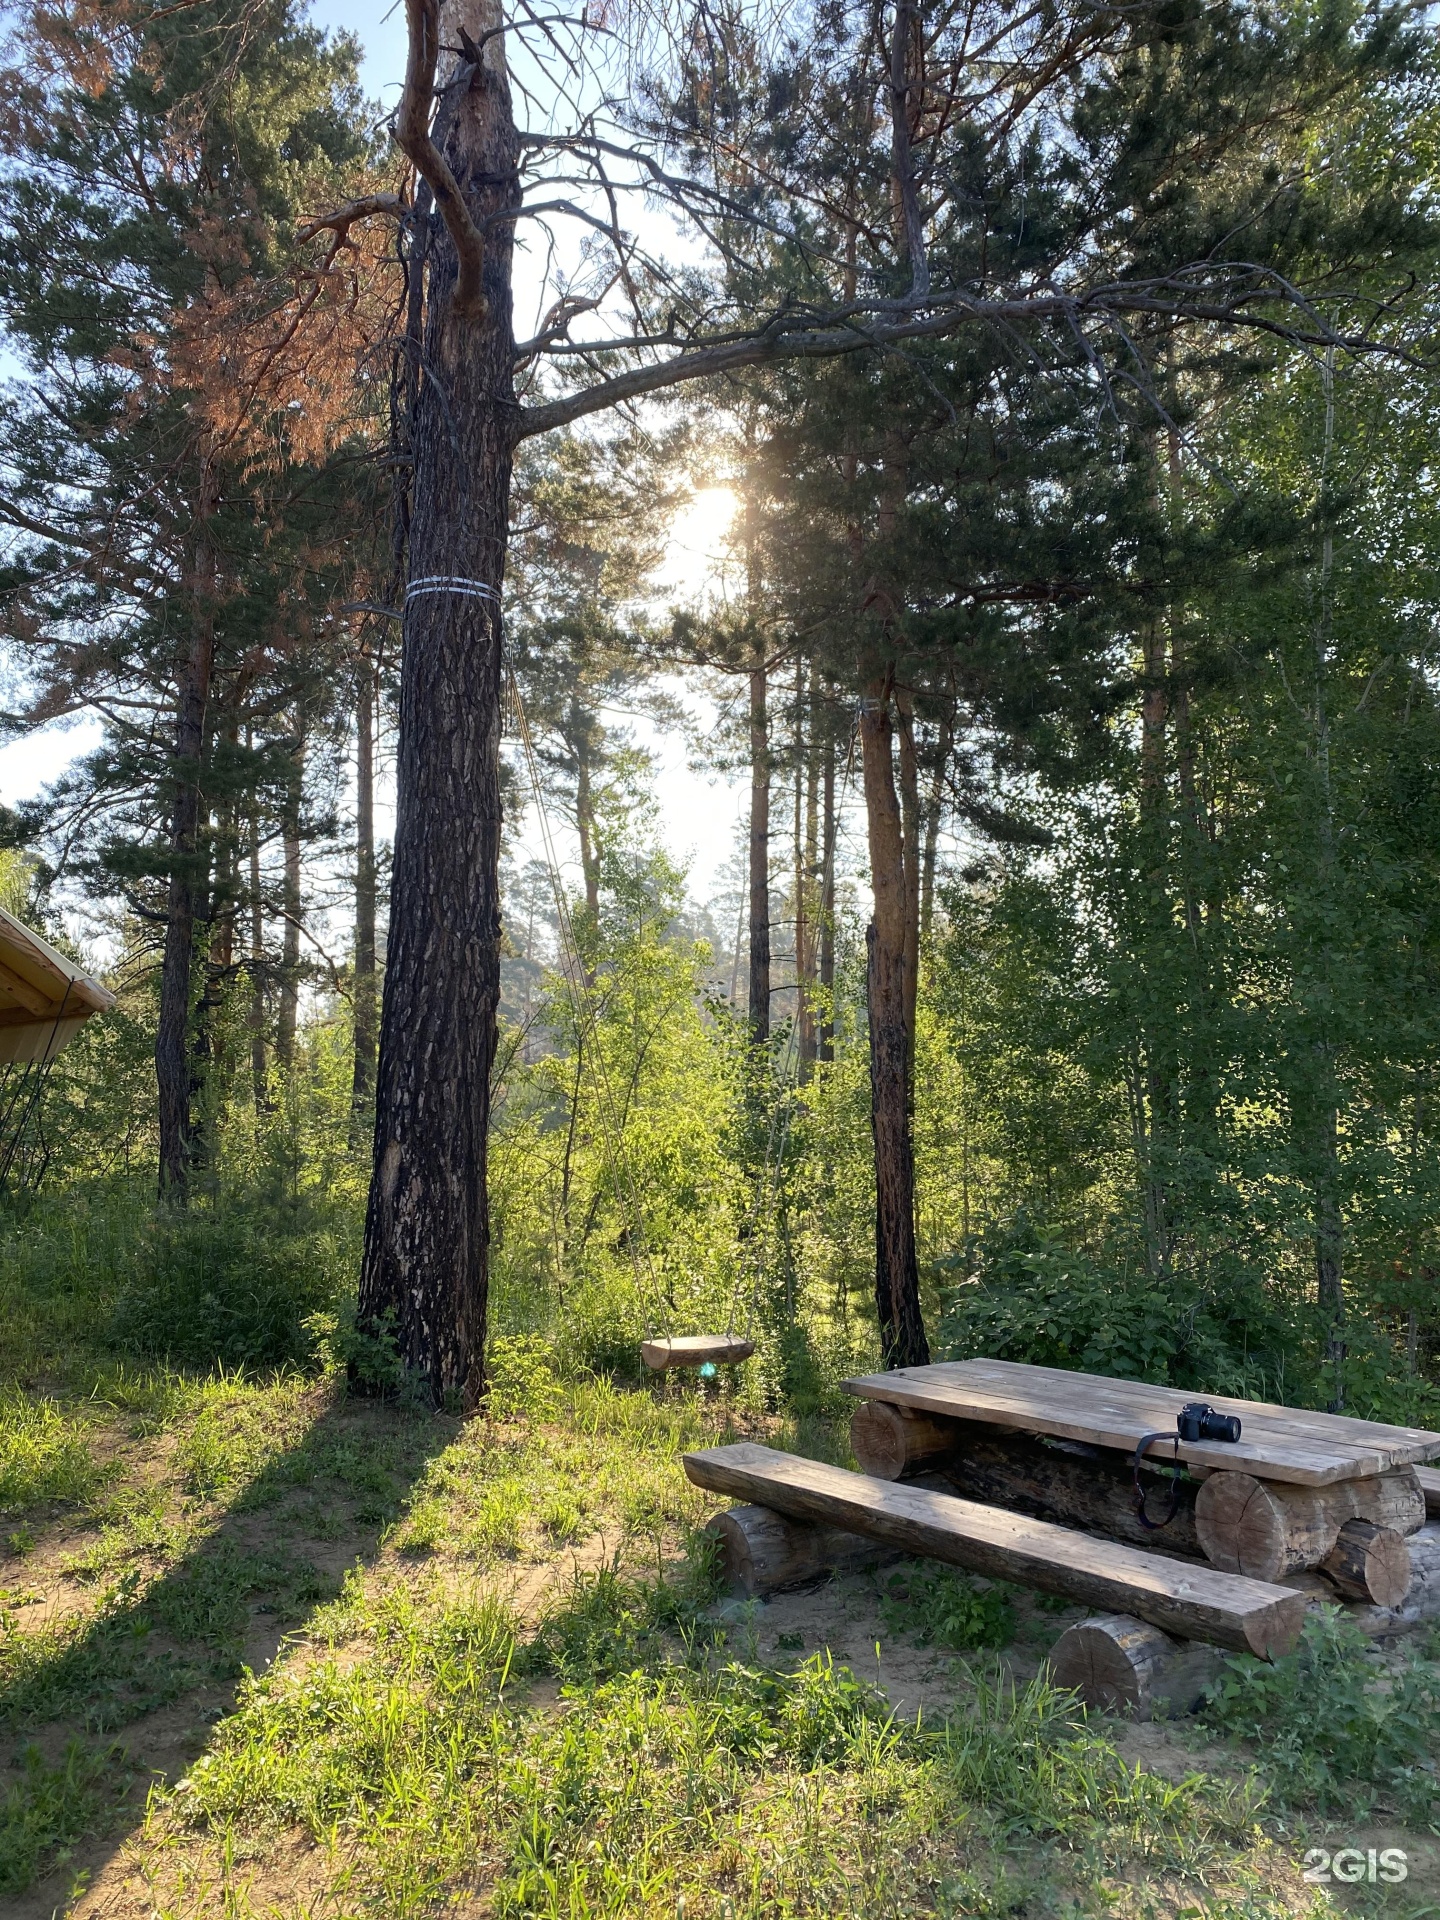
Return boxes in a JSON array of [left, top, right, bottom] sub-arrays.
[[0, 1302, 1440, 1920]]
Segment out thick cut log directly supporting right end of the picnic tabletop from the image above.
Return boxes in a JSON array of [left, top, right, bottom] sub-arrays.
[[1194, 1467, 1425, 1580]]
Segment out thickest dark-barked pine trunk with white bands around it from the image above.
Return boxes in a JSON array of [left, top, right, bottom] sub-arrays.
[[359, 8, 518, 1409]]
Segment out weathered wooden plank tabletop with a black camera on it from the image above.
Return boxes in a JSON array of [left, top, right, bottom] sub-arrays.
[[845, 1359, 1440, 1486]]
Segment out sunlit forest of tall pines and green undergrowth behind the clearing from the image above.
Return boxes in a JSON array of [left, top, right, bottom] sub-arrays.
[[0, 0, 1440, 1419]]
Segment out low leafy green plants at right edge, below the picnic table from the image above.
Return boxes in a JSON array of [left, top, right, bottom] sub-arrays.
[[1204, 1607, 1440, 1826]]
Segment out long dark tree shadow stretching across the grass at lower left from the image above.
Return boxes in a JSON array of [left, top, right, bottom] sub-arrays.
[[0, 1390, 461, 1920]]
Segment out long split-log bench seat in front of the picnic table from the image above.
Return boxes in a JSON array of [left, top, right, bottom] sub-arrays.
[[684, 1442, 1308, 1655]]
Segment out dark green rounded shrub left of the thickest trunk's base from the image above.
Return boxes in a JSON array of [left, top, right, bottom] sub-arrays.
[[111, 1202, 348, 1367]]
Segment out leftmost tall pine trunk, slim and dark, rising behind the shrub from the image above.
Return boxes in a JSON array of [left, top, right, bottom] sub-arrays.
[[156, 459, 219, 1202]]
